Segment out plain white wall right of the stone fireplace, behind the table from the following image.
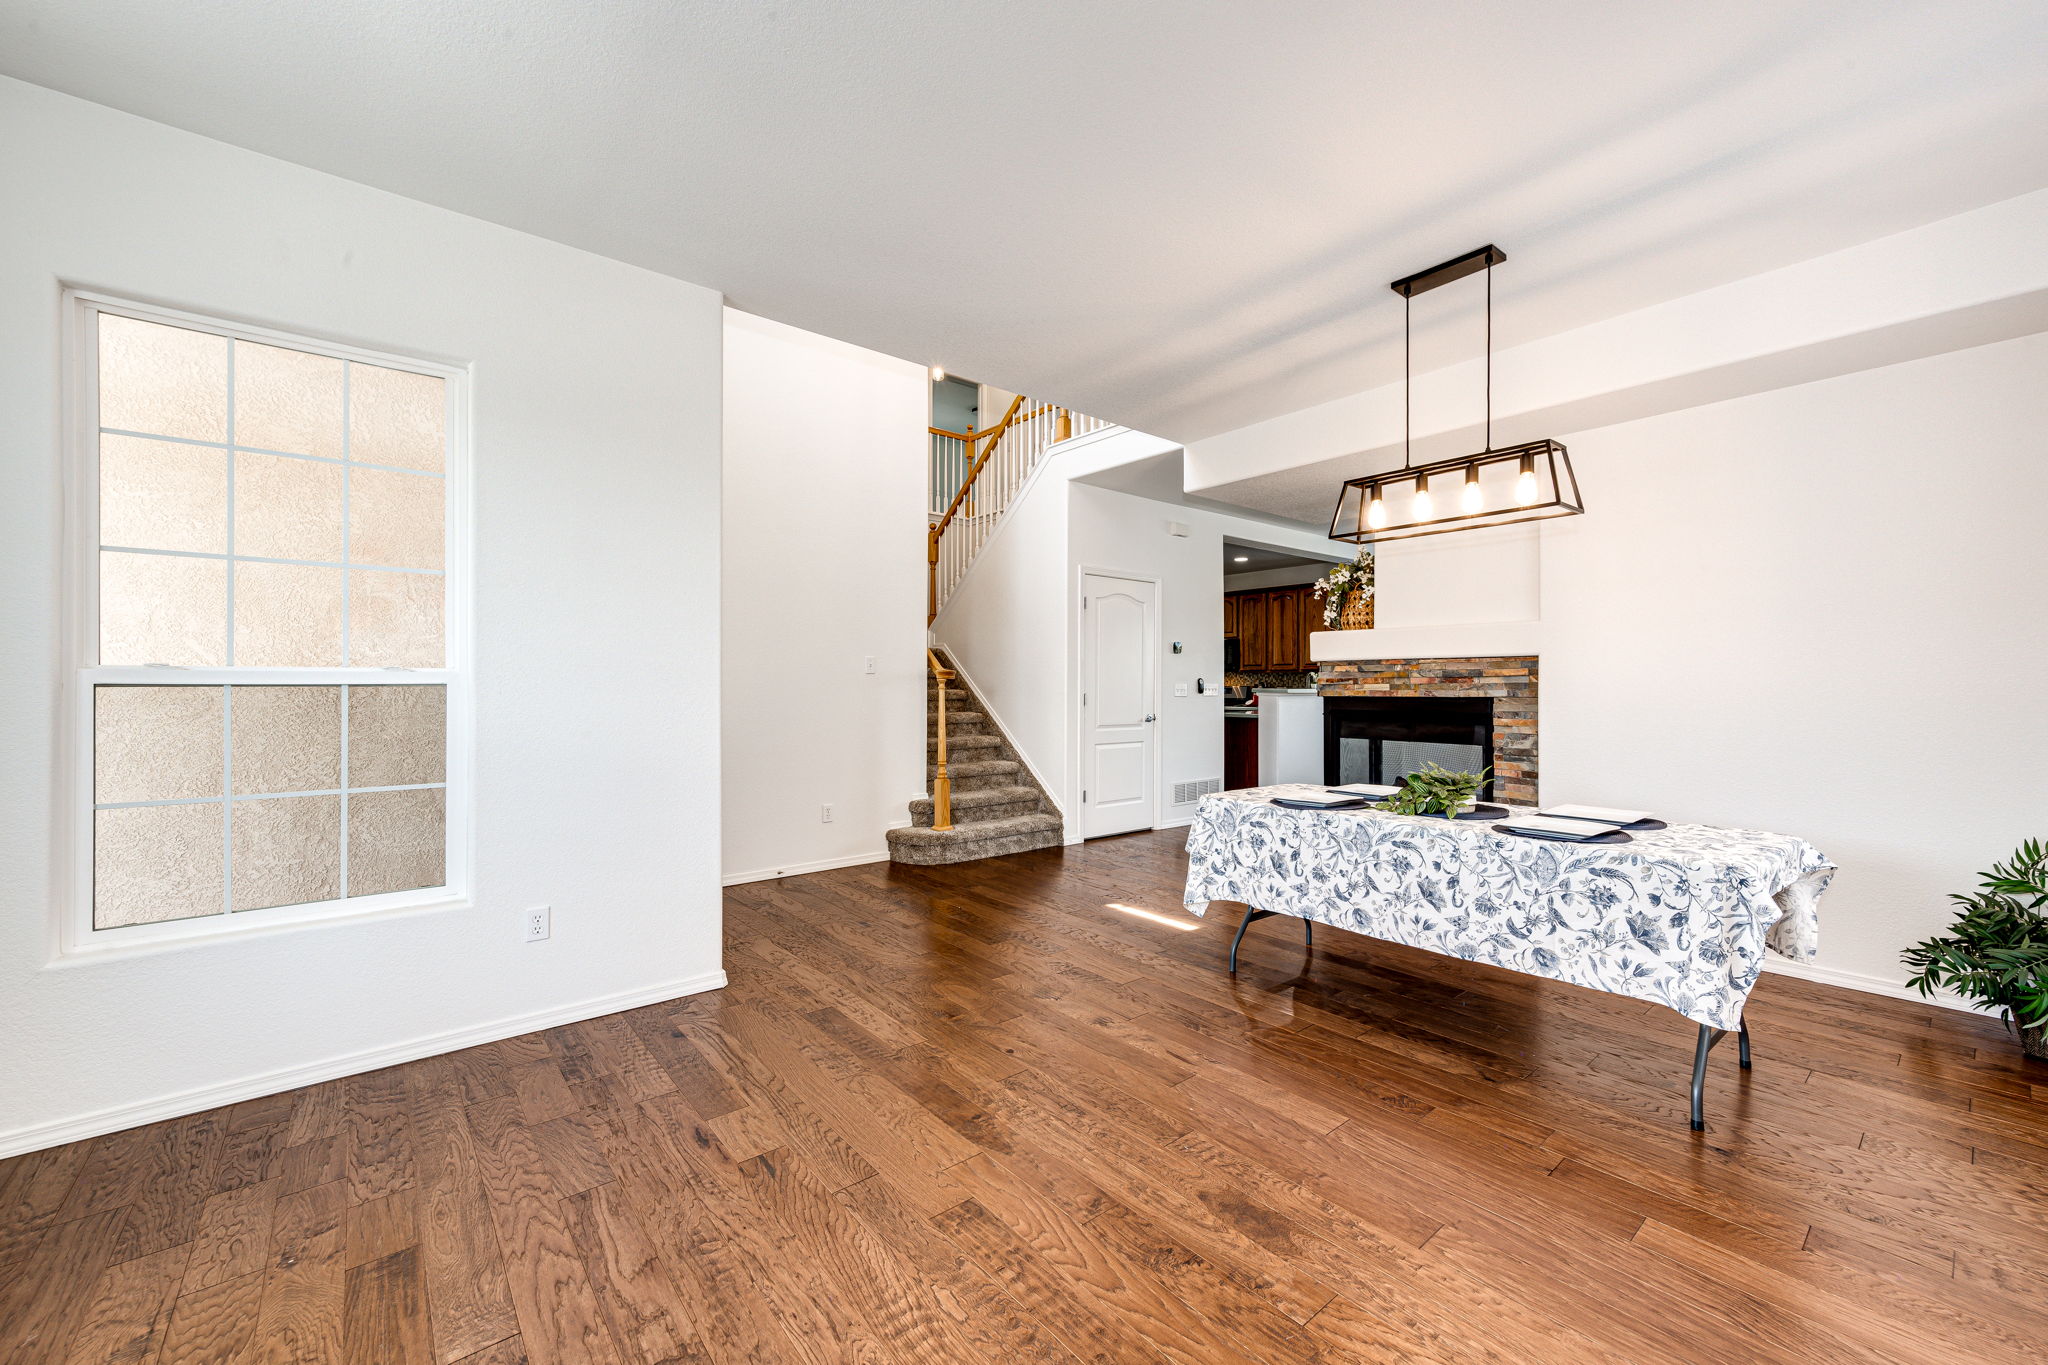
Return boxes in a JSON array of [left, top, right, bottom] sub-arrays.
[[1540, 336, 2048, 982]]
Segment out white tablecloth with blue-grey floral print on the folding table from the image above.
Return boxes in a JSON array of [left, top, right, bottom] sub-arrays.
[[1186, 786, 1835, 1029]]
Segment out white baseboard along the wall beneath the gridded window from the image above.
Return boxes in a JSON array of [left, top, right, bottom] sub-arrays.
[[0, 972, 725, 1158]]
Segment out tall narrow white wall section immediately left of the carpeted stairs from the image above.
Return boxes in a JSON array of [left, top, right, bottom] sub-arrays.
[[721, 309, 930, 882]]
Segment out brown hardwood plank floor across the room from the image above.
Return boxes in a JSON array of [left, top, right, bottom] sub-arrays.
[[0, 833, 2048, 1365]]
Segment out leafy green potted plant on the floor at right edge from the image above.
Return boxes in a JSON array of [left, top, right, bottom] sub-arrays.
[[1905, 839, 2048, 1062]]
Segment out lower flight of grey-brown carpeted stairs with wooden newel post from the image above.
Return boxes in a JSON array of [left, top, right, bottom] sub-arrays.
[[889, 661, 1065, 866]]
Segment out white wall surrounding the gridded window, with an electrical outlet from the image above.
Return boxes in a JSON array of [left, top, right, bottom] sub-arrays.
[[0, 80, 723, 1154]]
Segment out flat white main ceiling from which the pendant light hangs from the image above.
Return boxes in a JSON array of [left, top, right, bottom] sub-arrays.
[[0, 0, 2048, 440]]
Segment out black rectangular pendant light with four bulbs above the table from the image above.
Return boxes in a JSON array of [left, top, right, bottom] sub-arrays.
[[1329, 246, 1585, 544]]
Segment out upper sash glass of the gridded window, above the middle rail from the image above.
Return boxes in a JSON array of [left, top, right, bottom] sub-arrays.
[[98, 313, 446, 667]]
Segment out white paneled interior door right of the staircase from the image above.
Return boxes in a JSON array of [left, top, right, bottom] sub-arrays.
[[1081, 573, 1159, 839]]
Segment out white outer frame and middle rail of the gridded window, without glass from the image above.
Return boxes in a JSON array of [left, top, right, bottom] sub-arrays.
[[51, 289, 475, 966]]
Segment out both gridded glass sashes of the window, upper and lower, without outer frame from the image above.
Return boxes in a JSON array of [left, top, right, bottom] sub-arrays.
[[80, 305, 451, 931]]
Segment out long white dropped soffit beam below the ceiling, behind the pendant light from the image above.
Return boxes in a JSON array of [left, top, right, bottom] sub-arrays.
[[1182, 190, 2048, 530]]
